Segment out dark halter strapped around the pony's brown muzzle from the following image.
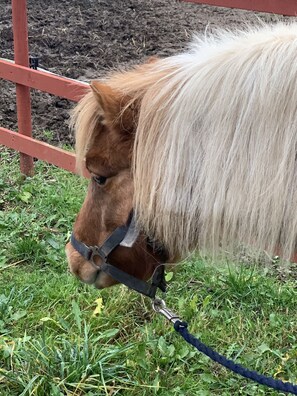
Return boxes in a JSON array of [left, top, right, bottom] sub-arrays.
[[70, 213, 166, 298]]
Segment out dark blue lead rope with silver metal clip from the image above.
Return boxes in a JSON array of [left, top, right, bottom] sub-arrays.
[[153, 299, 297, 395]]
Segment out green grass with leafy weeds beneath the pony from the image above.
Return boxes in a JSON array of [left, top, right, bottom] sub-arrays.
[[0, 148, 297, 396]]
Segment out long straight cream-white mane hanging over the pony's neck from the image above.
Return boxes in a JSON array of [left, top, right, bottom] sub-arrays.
[[134, 23, 297, 258]]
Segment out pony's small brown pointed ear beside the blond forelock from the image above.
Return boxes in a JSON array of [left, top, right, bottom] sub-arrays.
[[91, 81, 119, 117]]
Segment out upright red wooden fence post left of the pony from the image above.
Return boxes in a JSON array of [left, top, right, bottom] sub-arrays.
[[12, 0, 34, 176]]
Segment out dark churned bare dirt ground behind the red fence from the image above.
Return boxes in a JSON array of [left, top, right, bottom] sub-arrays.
[[0, 0, 290, 145]]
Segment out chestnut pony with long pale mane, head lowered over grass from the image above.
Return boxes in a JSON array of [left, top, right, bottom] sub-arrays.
[[66, 22, 297, 287]]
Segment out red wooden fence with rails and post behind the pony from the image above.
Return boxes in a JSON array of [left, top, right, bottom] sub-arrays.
[[0, 0, 297, 175]]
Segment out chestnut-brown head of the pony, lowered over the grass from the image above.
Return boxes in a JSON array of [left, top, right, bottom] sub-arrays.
[[66, 62, 167, 288]]
